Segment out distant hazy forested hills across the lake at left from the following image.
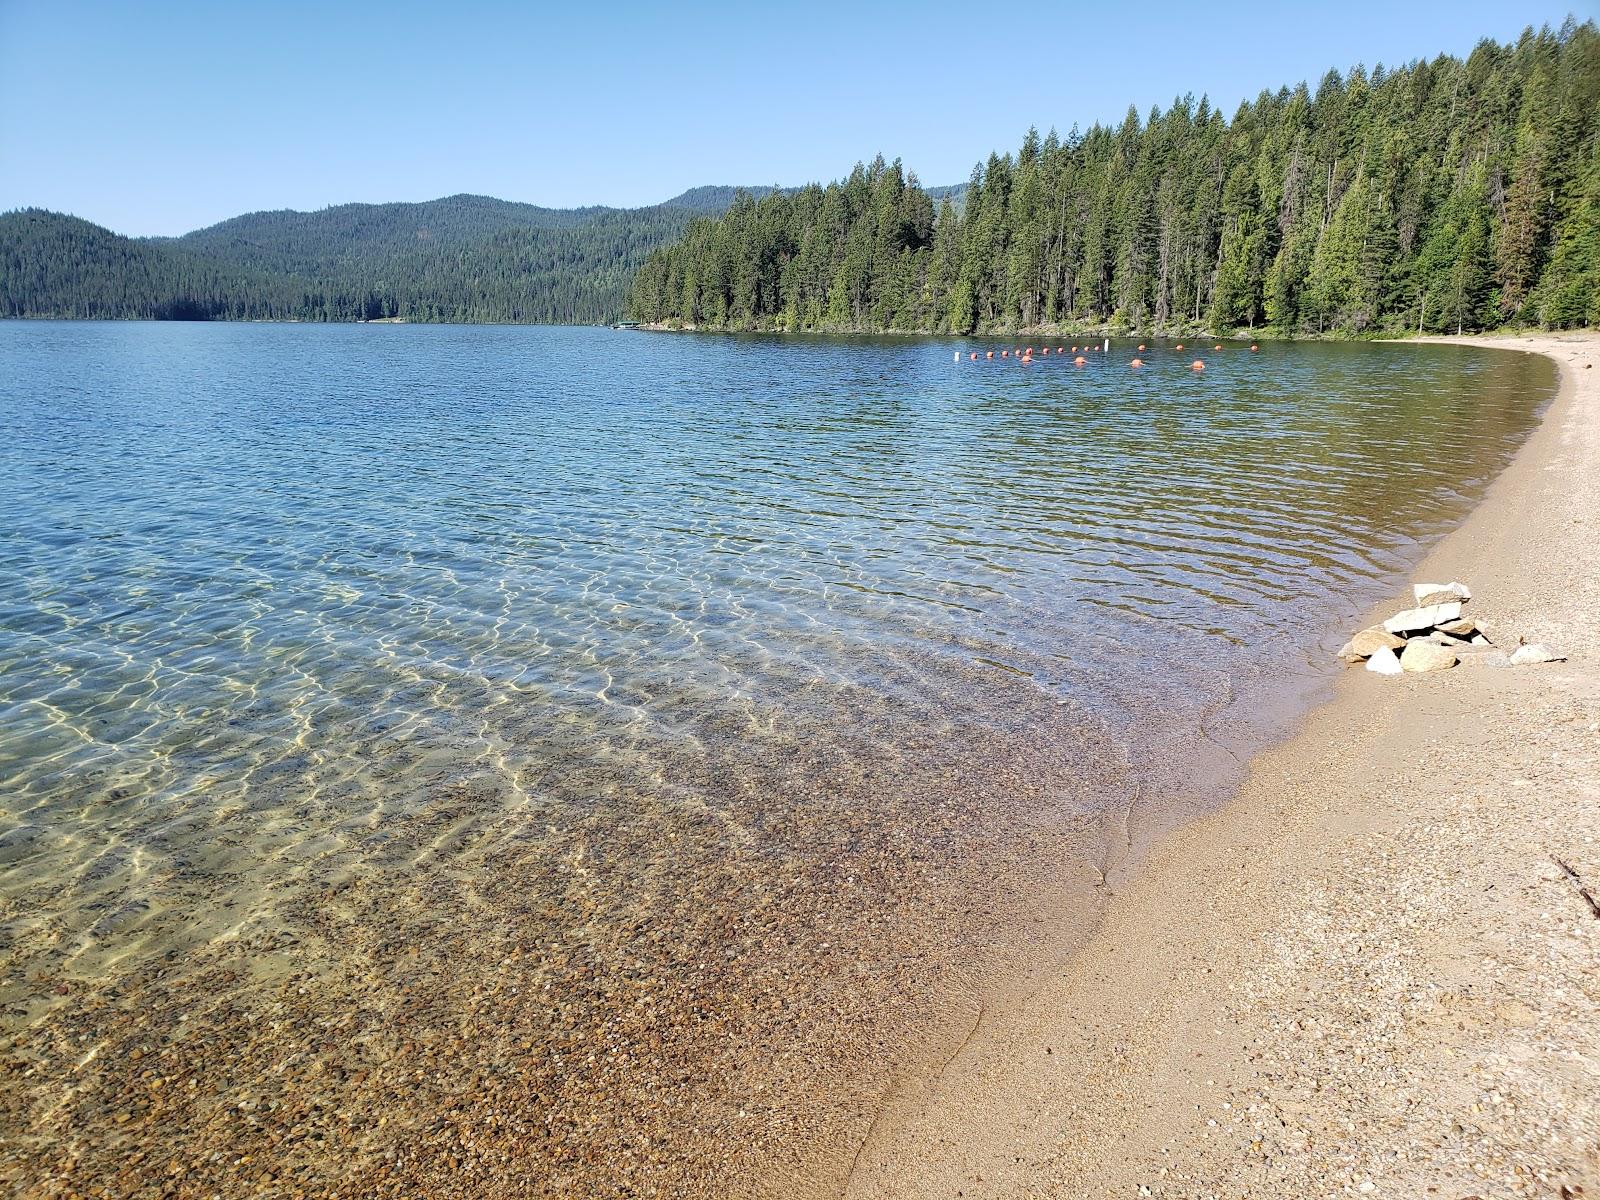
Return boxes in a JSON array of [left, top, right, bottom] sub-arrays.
[[0, 187, 780, 323]]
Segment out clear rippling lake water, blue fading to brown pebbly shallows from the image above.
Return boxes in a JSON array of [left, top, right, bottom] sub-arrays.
[[0, 323, 1555, 1195]]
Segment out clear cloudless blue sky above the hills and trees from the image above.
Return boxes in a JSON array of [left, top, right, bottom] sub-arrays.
[[0, 0, 1574, 234]]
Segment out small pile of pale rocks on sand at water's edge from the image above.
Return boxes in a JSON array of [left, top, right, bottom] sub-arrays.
[[1339, 582, 1566, 675]]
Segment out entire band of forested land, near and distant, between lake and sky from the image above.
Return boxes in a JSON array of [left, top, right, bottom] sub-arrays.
[[0, 19, 1600, 336]]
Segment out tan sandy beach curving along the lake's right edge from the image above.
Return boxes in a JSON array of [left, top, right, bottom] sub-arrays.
[[845, 334, 1600, 1198]]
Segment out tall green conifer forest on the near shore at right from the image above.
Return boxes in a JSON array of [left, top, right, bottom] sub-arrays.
[[630, 19, 1600, 334]]
